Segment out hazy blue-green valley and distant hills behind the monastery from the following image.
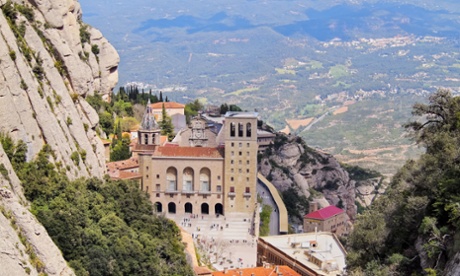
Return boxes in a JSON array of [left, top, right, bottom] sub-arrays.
[[81, 0, 460, 174]]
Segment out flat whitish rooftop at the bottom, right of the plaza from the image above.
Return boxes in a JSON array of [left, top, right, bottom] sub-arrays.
[[259, 232, 346, 275]]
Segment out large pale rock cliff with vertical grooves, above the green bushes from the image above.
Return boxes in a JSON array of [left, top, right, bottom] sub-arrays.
[[0, 0, 119, 178]]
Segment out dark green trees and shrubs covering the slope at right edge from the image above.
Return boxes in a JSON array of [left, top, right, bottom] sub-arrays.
[[347, 89, 460, 275]]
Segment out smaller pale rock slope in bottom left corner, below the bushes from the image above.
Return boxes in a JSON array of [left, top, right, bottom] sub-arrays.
[[0, 145, 74, 275]]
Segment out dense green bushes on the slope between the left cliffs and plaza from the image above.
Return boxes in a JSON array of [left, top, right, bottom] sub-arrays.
[[0, 138, 192, 275]]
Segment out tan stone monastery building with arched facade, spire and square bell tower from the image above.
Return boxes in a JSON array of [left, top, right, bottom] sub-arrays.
[[135, 108, 258, 219]]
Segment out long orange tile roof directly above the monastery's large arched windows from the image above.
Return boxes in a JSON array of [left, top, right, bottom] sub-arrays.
[[154, 147, 224, 158]]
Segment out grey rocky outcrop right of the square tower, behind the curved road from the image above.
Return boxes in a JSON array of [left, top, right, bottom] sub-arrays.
[[259, 134, 356, 220]]
